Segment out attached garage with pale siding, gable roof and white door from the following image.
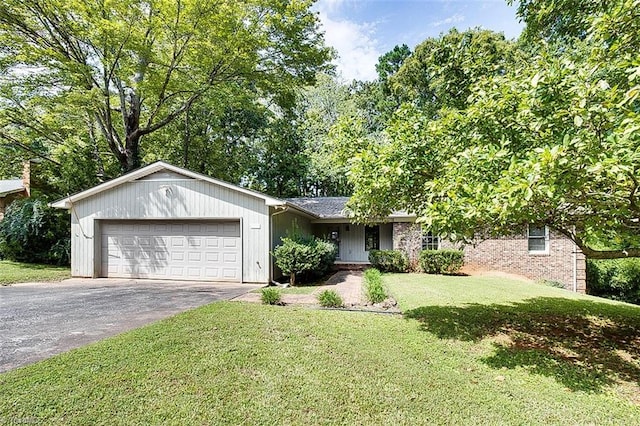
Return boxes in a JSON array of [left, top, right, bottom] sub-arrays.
[[52, 162, 286, 283]]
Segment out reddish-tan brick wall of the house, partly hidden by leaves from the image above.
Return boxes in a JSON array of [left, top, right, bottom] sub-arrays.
[[393, 223, 586, 293]]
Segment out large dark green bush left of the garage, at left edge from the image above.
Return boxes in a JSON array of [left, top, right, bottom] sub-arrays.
[[0, 197, 71, 265]]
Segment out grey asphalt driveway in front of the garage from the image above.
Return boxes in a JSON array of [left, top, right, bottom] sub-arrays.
[[0, 279, 259, 372]]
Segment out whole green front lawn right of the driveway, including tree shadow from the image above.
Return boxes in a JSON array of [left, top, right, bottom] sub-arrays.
[[0, 275, 640, 425]]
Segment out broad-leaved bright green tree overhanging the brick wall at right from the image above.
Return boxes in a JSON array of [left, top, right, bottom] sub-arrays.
[[351, 0, 640, 258]]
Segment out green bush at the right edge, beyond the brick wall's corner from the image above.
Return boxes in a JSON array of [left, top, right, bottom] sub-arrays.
[[587, 259, 640, 305]]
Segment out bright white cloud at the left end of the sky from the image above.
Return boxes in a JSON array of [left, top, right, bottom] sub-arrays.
[[318, 0, 381, 81]]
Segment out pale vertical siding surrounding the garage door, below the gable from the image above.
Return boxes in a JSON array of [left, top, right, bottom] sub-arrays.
[[71, 179, 269, 282]]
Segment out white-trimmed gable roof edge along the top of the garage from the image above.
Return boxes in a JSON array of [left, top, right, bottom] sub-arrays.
[[50, 161, 286, 209]]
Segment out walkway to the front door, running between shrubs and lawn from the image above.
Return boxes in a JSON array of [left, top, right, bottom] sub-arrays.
[[233, 271, 362, 307]]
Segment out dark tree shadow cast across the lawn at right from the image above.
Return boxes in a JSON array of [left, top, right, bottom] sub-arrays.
[[405, 297, 640, 391]]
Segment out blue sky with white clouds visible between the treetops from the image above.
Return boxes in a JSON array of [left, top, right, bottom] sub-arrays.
[[315, 0, 524, 81]]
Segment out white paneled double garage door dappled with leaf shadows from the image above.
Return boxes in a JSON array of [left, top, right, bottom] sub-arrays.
[[102, 220, 242, 281]]
